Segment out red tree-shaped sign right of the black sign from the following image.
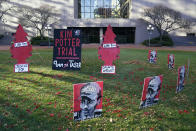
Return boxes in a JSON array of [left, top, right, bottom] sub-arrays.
[[98, 25, 120, 74]]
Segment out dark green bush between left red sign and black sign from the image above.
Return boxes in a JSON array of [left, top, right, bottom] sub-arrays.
[[30, 36, 54, 46]]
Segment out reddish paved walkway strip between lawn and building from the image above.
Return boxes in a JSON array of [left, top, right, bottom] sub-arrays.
[[0, 44, 196, 52]]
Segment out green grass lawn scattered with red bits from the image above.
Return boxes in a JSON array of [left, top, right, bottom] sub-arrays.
[[0, 48, 196, 131]]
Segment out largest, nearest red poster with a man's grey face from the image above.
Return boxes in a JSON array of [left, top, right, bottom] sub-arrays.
[[73, 81, 103, 121]]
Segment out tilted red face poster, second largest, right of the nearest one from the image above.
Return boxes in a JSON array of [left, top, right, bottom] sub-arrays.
[[140, 75, 163, 108]]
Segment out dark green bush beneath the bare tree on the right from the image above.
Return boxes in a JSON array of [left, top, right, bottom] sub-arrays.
[[142, 35, 174, 46]]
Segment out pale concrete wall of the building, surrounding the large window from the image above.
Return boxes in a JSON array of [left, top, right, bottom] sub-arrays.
[[0, 0, 196, 43]]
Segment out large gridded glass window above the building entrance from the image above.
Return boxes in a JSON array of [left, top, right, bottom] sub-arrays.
[[78, 0, 129, 19]]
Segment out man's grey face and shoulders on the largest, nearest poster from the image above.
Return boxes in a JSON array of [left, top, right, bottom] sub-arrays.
[[74, 82, 102, 121]]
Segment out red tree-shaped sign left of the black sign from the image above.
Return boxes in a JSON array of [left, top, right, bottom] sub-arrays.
[[10, 25, 32, 72]]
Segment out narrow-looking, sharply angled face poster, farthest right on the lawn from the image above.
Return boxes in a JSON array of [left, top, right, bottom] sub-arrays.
[[176, 66, 186, 93]]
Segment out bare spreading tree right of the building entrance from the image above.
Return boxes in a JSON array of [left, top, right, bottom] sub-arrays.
[[144, 5, 191, 41]]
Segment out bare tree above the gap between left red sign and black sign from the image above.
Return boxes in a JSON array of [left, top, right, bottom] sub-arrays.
[[19, 5, 58, 39]]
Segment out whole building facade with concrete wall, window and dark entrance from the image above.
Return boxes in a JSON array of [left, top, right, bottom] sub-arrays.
[[1, 0, 196, 44]]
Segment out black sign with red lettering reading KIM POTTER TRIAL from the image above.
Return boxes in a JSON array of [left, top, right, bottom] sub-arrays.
[[52, 29, 82, 70]]
